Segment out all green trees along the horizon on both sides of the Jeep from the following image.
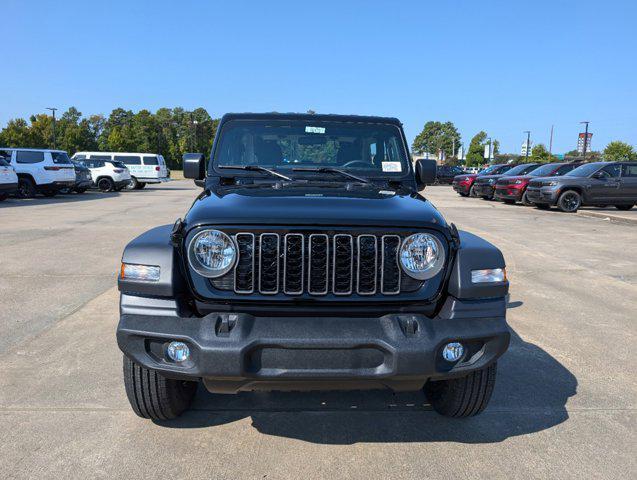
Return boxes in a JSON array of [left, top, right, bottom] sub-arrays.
[[0, 107, 637, 169]]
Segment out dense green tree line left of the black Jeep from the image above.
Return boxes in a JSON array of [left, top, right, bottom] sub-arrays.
[[0, 107, 219, 169]]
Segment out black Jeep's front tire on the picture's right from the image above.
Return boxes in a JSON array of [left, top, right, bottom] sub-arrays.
[[425, 363, 497, 418]]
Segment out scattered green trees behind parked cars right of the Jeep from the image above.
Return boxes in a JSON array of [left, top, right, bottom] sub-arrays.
[[411, 121, 637, 167]]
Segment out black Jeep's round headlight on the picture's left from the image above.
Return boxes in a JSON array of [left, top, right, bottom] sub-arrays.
[[188, 230, 237, 278]]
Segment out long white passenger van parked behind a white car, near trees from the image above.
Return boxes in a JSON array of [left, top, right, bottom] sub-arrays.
[[73, 152, 169, 190]]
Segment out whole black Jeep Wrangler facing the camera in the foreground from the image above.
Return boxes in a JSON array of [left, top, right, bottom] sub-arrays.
[[117, 114, 509, 419]]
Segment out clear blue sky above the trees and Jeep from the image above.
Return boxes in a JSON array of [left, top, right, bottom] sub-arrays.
[[0, 0, 637, 153]]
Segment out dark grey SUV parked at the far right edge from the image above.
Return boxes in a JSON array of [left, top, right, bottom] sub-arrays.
[[527, 162, 637, 212]]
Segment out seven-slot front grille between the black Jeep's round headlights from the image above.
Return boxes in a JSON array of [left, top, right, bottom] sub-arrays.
[[226, 232, 404, 296]]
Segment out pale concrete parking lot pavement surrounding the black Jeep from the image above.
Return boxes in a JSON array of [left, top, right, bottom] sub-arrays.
[[0, 181, 637, 479]]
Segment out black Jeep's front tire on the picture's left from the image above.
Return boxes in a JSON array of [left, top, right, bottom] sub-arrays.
[[124, 356, 197, 420]]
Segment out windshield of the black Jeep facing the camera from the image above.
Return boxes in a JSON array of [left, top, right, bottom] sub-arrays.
[[213, 119, 410, 180]]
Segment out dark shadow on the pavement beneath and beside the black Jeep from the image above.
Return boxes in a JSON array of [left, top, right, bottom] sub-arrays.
[[156, 331, 577, 445]]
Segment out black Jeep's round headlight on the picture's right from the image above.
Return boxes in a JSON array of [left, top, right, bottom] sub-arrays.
[[400, 233, 445, 280]]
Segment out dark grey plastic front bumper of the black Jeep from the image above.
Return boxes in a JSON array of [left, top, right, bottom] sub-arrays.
[[117, 294, 510, 393]]
